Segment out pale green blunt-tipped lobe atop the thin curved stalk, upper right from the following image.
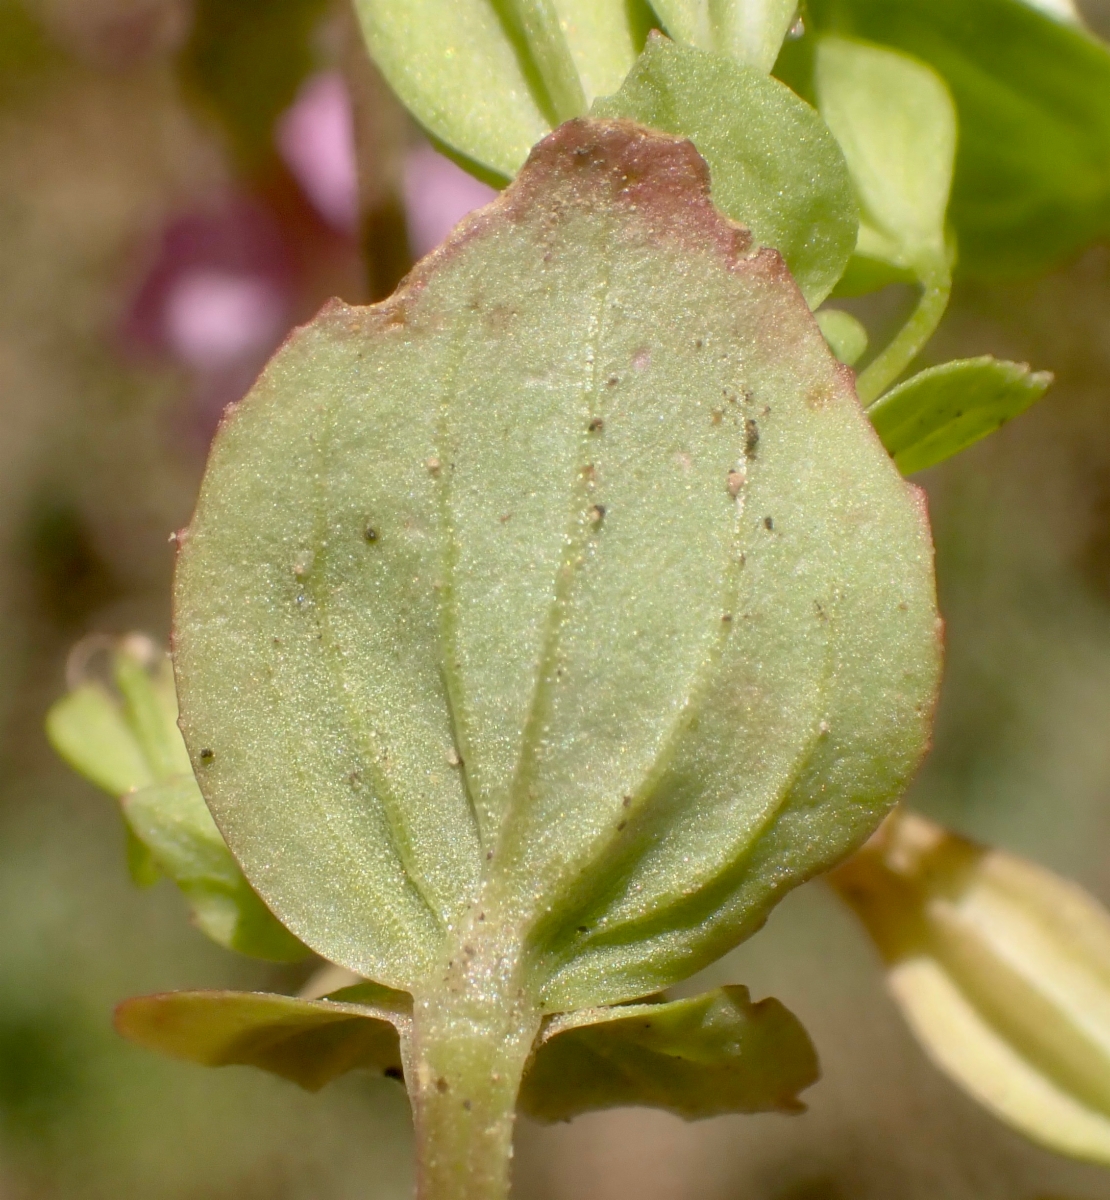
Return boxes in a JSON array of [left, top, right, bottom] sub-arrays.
[[814, 37, 956, 278]]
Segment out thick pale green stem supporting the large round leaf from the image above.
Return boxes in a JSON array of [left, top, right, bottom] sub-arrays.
[[404, 944, 540, 1200]]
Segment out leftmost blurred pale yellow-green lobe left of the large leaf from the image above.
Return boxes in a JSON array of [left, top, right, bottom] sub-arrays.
[[46, 683, 154, 798]]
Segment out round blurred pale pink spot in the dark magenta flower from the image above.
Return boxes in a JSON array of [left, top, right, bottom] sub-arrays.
[[163, 268, 286, 371]]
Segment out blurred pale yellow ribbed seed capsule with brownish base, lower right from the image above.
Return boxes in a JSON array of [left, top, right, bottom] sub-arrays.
[[830, 812, 1110, 1163]]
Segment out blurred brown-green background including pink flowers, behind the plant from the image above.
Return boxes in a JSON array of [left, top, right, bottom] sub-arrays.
[[0, 0, 1110, 1200]]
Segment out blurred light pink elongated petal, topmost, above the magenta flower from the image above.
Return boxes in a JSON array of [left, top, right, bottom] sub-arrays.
[[276, 71, 359, 234]]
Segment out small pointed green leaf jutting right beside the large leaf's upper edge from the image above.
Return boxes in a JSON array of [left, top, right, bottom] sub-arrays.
[[868, 356, 1052, 475]]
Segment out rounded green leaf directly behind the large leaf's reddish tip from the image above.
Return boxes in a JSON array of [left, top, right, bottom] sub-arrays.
[[593, 34, 858, 307]]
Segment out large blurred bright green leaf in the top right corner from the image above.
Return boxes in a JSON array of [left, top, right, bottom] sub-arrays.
[[808, 0, 1110, 276]]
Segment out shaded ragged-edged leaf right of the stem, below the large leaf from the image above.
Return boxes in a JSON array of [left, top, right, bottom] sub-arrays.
[[521, 986, 820, 1121]]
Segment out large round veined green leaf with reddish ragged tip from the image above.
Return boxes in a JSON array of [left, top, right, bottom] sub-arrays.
[[175, 121, 938, 1012]]
